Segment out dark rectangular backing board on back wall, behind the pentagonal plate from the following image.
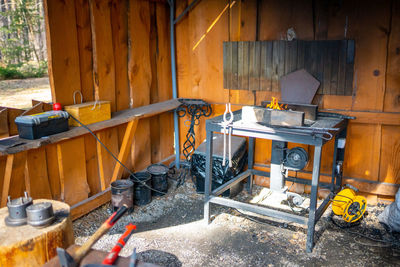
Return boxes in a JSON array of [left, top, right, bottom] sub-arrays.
[[223, 40, 355, 95]]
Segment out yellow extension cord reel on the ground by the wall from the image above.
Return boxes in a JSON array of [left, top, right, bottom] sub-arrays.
[[332, 184, 367, 223]]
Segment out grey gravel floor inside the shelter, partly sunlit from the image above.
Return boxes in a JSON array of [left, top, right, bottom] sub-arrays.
[[74, 176, 400, 266]]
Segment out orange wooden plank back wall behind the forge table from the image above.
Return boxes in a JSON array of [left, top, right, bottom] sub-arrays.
[[176, 0, 400, 201]]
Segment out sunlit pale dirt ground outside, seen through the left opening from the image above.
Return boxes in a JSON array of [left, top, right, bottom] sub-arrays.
[[0, 77, 51, 109]]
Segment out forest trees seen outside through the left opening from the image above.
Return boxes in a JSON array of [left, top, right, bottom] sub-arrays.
[[0, 0, 47, 80]]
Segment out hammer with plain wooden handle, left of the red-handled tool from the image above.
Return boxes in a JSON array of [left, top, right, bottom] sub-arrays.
[[57, 205, 128, 267]]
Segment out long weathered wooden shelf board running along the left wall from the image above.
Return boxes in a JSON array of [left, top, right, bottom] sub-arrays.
[[0, 99, 181, 155]]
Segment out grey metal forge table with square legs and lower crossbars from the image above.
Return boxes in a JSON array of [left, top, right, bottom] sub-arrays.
[[204, 110, 348, 252]]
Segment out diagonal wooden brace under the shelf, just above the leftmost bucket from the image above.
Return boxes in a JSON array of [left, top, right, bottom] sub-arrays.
[[111, 119, 138, 183]]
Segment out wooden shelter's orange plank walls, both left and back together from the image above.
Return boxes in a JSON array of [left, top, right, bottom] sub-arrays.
[[0, 0, 400, 218]]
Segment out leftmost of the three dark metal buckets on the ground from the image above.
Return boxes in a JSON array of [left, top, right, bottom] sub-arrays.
[[111, 180, 133, 212]]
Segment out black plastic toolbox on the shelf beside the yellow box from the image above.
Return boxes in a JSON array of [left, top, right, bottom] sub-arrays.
[[15, 111, 69, 140]]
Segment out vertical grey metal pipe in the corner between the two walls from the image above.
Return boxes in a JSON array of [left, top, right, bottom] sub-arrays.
[[168, 0, 180, 169]]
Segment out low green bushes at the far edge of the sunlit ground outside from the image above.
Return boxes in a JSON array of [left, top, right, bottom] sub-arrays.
[[0, 61, 47, 80]]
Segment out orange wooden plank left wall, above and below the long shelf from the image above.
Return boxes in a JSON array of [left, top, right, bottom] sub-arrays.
[[0, 0, 174, 209]]
